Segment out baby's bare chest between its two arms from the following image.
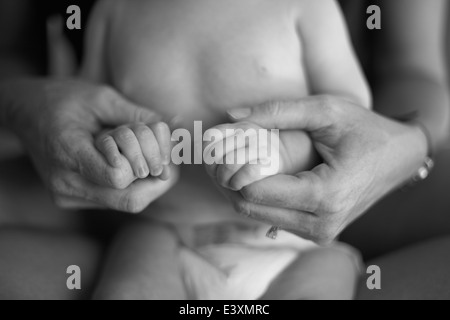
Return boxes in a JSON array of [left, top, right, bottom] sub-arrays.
[[107, 0, 307, 126]]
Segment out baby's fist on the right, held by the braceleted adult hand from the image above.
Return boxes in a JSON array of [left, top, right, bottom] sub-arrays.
[[203, 122, 317, 191]]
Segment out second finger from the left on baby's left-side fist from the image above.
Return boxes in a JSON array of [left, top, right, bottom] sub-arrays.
[[113, 127, 150, 179]]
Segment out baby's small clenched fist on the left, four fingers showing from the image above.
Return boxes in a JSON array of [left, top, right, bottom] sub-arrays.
[[95, 122, 172, 180]]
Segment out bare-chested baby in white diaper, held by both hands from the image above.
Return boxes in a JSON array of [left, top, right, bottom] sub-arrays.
[[81, 0, 370, 299]]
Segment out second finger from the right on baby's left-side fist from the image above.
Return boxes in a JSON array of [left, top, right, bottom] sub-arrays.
[[133, 124, 163, 177]]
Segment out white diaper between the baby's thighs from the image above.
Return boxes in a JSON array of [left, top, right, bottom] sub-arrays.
[[180, 227, 316, 300]]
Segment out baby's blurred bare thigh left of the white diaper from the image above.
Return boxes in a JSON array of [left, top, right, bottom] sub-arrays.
[[94, 219, 185, 300]]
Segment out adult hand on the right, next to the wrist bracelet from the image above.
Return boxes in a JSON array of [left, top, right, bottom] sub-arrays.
[[225, 96, 427, 243]]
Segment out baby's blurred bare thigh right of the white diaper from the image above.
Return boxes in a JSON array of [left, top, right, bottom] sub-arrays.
[[263, 244, 361, 300]]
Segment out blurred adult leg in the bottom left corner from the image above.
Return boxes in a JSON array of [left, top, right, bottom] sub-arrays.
[[0, 228, 101, 300]]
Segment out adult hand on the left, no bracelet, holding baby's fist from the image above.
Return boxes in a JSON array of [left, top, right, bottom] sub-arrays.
[[1, 80, 177, 213]]
